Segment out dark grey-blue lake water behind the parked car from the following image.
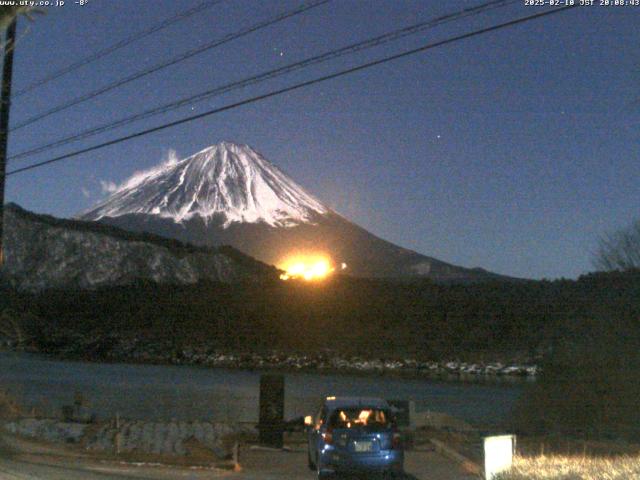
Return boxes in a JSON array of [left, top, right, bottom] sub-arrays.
[[0, 352, 524, 426]]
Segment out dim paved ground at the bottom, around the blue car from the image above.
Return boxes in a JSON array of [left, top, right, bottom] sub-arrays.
[[0, 437, 477, 480]]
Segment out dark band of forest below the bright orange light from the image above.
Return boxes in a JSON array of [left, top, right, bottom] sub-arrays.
[[0, 272, 640, 360]]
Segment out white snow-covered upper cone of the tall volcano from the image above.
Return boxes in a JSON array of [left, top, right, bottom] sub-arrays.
[[81, 142, 330, 227]]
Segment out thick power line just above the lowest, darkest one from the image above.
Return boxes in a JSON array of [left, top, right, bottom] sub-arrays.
[[9, 0, 520, 161]]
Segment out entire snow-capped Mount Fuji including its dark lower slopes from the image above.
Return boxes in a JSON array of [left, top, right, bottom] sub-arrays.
[[78, 142, 505, 282]]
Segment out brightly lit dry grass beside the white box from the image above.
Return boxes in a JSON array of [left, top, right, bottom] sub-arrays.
[[498, 455, 640, 480]]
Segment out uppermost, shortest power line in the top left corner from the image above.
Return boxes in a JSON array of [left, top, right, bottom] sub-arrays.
[[13, 0, 223, 98]]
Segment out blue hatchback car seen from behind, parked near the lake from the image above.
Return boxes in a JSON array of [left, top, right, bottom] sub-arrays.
[[305, 397, 404, 478]]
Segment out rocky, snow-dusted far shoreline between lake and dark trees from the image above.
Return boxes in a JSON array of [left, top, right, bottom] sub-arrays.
[[4, 337, 540, 381]]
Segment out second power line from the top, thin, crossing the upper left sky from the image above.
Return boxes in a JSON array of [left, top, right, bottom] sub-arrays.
[[11, 0, 331, 131]]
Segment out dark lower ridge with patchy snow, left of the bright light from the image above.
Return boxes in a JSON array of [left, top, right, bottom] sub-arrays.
[[3, 204, 278, 290]]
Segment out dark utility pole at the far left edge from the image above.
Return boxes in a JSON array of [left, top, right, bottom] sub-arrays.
[[0, 16, 18, 266]]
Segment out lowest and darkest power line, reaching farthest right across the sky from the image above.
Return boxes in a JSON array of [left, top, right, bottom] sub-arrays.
[[7, 5, 577, 176]]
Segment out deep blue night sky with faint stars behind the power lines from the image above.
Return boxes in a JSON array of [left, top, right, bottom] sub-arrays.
[[6, 0, 640, 278]]
